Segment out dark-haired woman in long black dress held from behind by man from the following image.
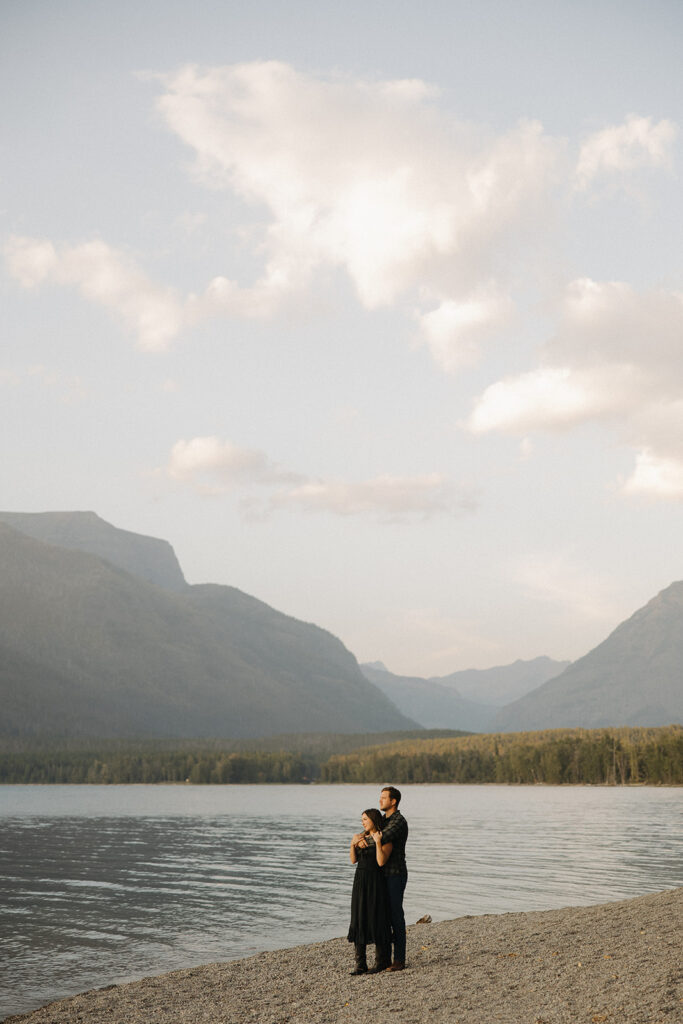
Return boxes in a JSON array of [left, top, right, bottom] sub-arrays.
[[348, 807, 391, 974]]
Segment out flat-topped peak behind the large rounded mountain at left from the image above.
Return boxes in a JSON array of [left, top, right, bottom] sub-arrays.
[[0, 512, 187, 592]]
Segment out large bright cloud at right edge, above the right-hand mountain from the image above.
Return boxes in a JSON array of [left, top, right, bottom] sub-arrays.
[[466, 279, 683, 498]]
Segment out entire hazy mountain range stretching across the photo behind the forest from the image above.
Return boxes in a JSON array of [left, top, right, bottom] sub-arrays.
[[0, 512, 683, 738]]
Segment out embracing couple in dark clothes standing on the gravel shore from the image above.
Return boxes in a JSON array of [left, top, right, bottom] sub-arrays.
[[348, 785, 408, 975]]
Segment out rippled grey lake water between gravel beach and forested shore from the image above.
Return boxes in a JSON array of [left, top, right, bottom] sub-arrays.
[[0, 785, 683, 1018]]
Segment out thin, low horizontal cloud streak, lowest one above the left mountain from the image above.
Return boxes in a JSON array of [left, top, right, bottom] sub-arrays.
[[166, 436, 474, 522]]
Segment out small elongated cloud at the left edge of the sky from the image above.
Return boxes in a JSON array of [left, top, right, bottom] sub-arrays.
[[5, 237, 185, 351]]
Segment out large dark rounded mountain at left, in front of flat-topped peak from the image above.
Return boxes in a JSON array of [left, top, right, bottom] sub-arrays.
[[0, 513, 415, 737]]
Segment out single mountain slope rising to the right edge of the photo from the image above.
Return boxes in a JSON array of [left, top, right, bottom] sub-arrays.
[[496, 583, 683, 731]]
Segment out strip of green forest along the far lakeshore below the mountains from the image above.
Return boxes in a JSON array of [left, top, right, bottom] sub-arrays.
[[0, 725, 683, 785]]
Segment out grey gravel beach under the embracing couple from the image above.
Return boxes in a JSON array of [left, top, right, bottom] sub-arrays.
[[6, 889, 683, 1024]]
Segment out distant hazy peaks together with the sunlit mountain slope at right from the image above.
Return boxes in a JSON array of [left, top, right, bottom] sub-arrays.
[[368, 583, 683, 732]]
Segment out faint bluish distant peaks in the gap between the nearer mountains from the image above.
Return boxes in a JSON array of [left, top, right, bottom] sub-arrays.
[[360, 657, 569, 732]]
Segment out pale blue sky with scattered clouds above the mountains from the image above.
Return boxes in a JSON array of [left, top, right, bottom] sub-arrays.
[[0, 0, 683, 676]]
